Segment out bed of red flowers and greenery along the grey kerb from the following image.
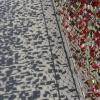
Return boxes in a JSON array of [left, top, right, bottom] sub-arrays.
[[54, 0, 100, 100]]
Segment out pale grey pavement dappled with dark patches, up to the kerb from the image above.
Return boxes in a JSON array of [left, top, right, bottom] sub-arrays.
[[0, 0, 81, 100]]
